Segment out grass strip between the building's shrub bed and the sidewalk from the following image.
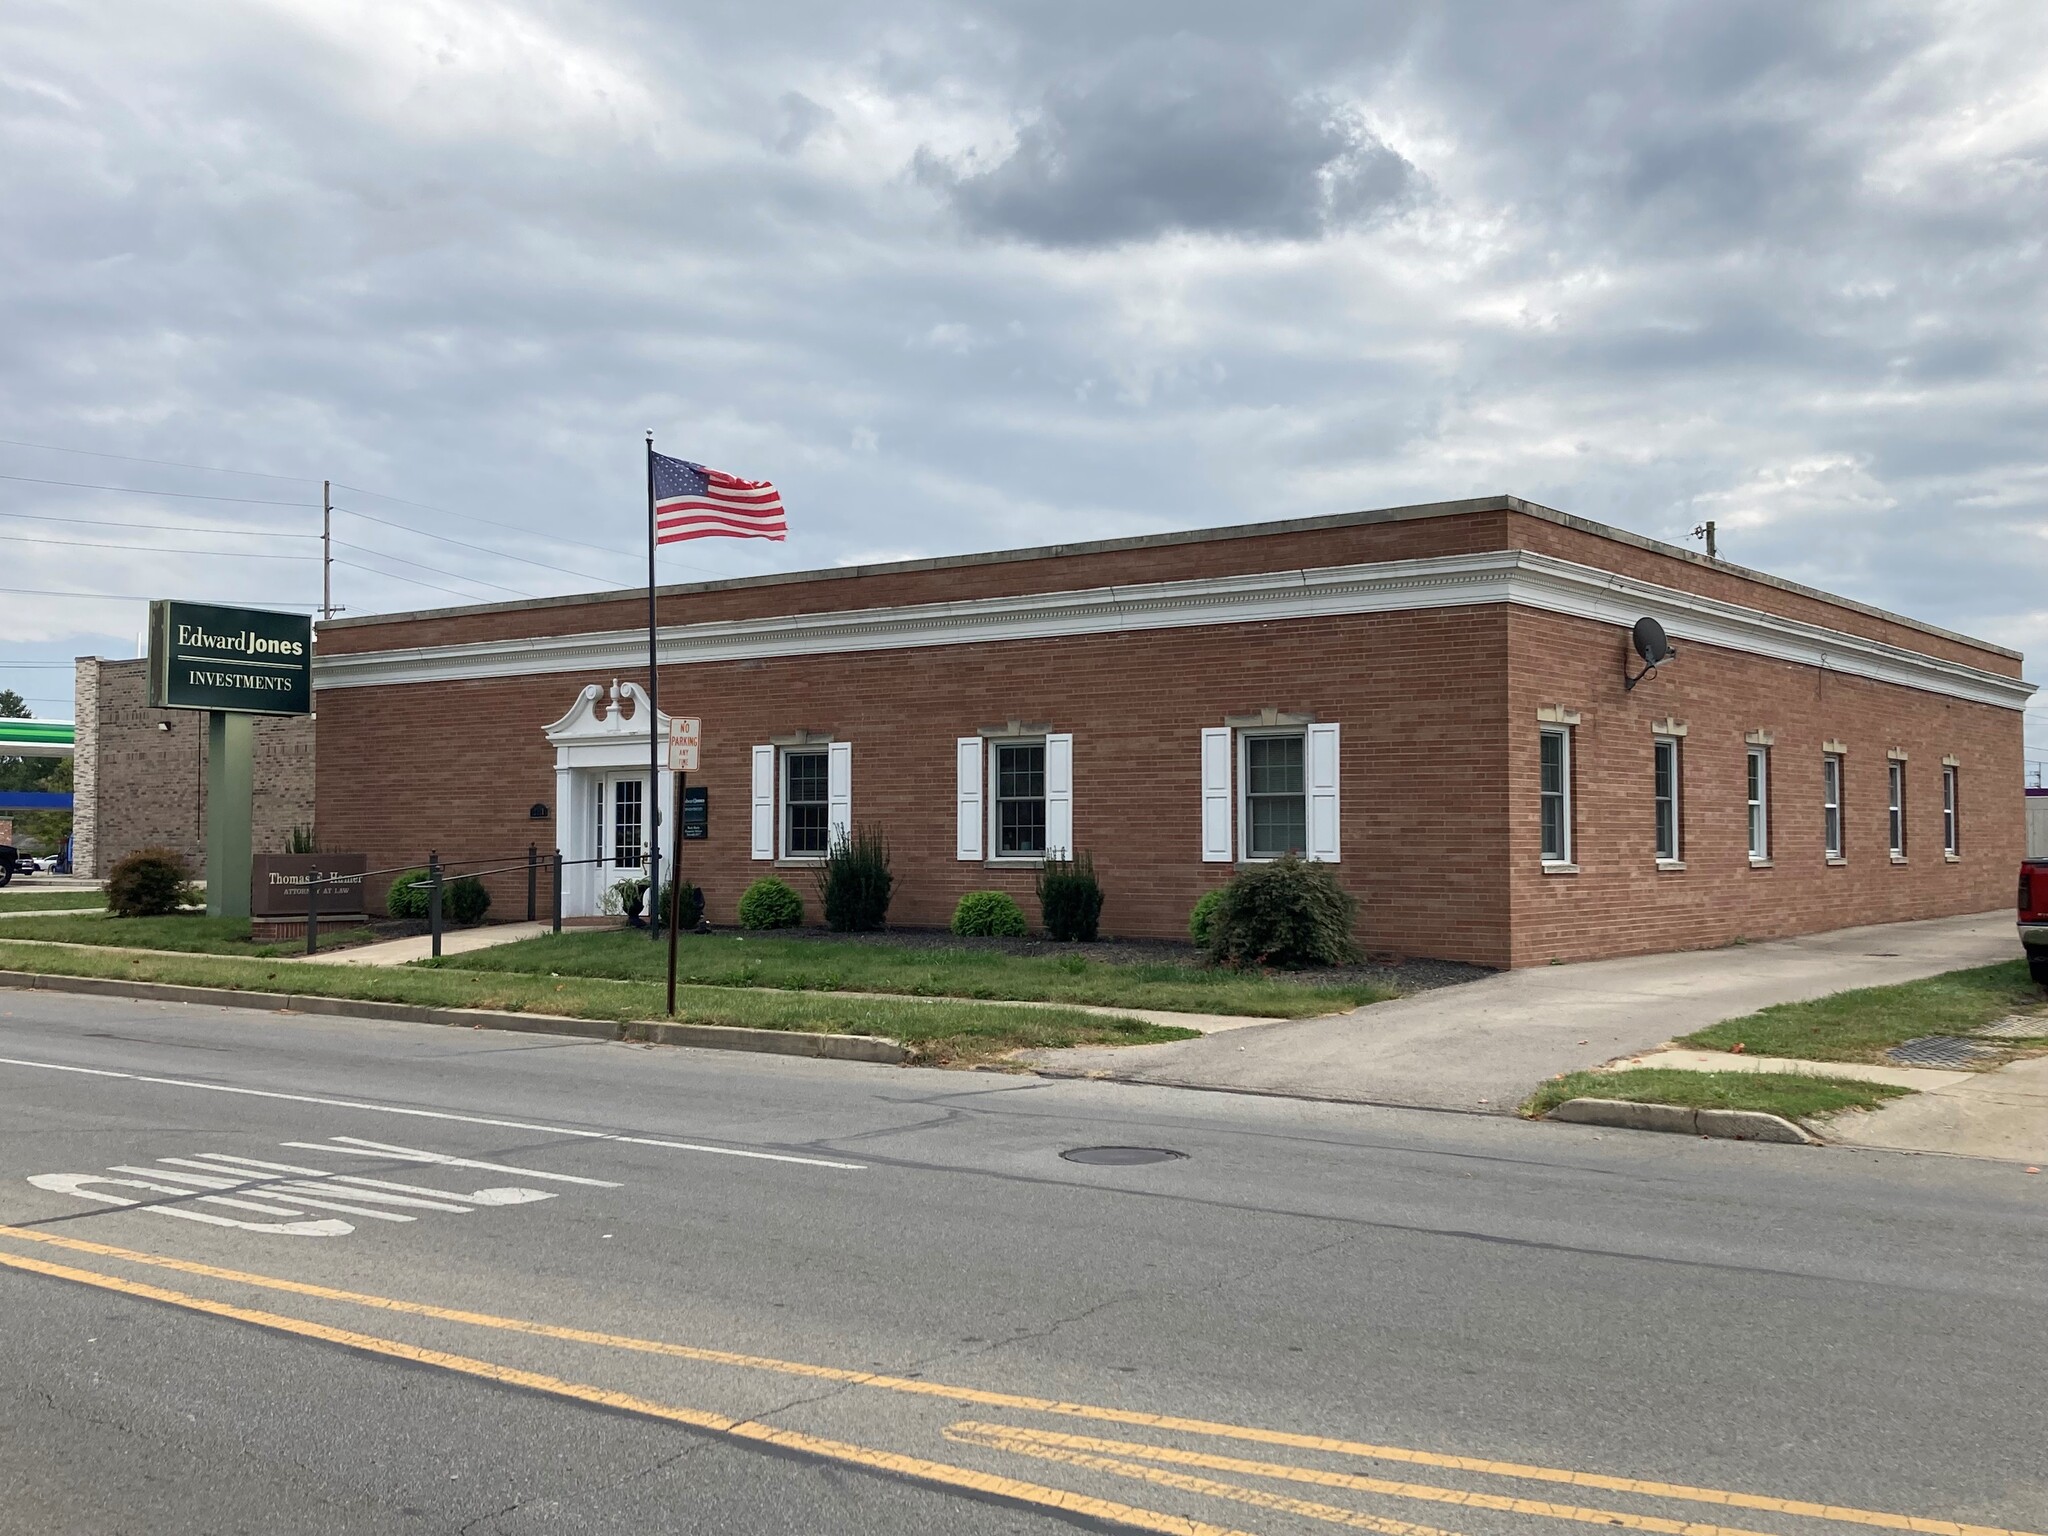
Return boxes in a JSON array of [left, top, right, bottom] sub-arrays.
[[442, 930, 1395, 1018]]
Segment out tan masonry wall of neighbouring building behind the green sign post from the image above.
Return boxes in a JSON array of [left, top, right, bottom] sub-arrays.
[[72, 655, 315, 879]]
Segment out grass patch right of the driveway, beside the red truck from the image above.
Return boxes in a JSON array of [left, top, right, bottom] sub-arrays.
[[1679, 961, 2048, 1061]]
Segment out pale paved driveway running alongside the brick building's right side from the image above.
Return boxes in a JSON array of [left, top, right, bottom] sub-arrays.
[[1024, 909, 2019, 1114]]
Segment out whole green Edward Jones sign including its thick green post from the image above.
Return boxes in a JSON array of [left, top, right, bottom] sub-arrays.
[[150, 600, 313, 918]]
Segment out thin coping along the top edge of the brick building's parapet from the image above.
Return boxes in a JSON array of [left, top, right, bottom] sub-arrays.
[[319, 496, 2021, 662]]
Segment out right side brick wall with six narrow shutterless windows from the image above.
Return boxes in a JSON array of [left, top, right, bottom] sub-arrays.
[[1507, 608, 2025, 965]]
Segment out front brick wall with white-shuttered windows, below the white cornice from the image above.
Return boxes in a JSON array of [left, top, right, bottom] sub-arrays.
[[319, 608, 1507, 963]]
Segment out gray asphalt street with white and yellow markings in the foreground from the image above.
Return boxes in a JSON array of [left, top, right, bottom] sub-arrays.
[[0, 993, 2048, 1536]]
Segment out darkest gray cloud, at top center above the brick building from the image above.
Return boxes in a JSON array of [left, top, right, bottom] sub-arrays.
[[915, 35, 1415, 246]]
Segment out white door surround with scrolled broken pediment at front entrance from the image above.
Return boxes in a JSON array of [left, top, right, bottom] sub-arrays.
[[547, 682, 676, 918]]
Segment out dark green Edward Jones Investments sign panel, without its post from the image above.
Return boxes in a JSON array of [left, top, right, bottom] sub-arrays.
[[150, 600, 313, 715]]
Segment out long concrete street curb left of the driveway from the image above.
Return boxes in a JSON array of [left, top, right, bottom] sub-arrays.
[[0, 971, 909, 1067]]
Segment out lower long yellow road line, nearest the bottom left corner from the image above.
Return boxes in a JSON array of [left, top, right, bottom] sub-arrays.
[[0, 1253, 1251, 1536]]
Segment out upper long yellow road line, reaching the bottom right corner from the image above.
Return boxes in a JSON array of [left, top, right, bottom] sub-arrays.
[[0, 1225, 2034, 1536]]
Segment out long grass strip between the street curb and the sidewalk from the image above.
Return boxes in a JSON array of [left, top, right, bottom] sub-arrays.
[[0, 938, 1194, 1065]]
